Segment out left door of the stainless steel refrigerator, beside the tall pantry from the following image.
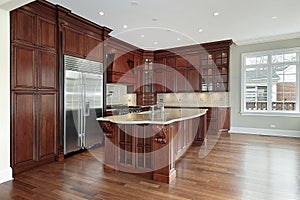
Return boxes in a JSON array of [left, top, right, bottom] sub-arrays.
[[64, 70, 84, 154]]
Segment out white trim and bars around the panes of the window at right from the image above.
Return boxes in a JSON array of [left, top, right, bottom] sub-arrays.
[[240, 47, 300, 117]]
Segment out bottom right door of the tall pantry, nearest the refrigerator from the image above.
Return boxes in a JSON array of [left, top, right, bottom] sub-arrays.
[[37, 93, 58, 159]]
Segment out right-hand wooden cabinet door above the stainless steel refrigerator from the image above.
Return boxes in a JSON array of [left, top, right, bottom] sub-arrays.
[[85, 34, 103, 62]]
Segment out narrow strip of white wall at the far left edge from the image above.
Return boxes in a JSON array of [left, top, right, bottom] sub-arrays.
[[0, 0, 32, 183]]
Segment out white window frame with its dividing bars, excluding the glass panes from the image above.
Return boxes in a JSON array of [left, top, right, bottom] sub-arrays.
[[241, 47, 300, 117]]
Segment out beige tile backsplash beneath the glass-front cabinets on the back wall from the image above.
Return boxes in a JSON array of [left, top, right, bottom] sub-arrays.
[[157, 92, 230, 107]]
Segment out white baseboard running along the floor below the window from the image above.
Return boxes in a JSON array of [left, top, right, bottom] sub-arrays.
[[229, 127, 300, 138]]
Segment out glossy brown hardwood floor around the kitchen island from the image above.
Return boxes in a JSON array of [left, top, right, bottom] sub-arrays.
[[0, 134, 300, 200]]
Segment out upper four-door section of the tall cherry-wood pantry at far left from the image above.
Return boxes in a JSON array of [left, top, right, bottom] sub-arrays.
[[11, 3, 59, 90]]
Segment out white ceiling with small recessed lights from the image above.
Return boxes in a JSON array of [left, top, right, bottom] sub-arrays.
[[48, 0, 300, 50]]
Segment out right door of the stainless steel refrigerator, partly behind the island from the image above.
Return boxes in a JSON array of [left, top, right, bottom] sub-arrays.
[[82, 73, 104, 148]]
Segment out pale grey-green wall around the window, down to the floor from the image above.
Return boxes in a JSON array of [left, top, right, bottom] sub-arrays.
[[230, 38, 300, 137]]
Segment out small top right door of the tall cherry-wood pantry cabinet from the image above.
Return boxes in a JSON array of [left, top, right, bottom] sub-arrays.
[[37, 17, 57, 50]]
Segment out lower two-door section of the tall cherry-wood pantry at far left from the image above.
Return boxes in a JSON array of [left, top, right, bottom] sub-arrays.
[[11, 91, 58, 174]]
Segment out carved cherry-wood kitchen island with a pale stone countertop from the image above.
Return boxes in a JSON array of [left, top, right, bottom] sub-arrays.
[[97, 108, 207, 183]]
